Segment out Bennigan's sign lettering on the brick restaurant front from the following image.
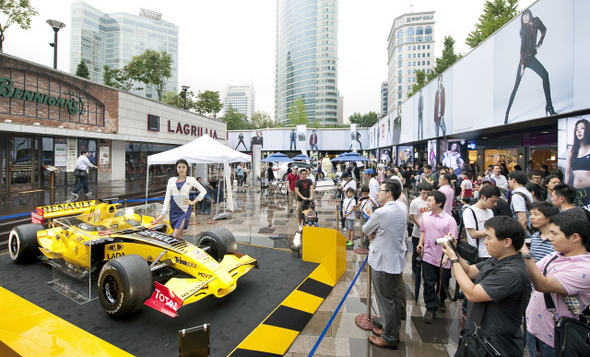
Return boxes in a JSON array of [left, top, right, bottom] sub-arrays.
[[0, 77, 85, 115]]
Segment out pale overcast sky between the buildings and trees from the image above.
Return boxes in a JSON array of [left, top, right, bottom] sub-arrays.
[[0, 0, 536, 122]]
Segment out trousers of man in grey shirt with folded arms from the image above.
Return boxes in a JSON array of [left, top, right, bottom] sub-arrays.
[[371, 268, 402, 345]]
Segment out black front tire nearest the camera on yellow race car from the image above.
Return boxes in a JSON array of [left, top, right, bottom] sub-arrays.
[[98, 255, 154, 318]]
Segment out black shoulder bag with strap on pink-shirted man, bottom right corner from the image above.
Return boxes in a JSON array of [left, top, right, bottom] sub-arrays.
[[543, 255, 590, 357]]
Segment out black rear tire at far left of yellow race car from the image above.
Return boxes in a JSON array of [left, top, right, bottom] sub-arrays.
[[8, 223, 45, 264]]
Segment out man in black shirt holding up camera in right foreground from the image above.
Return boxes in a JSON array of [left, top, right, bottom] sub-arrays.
[[443, 216, 531, 356]]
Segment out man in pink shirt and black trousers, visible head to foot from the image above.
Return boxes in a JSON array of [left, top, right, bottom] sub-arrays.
[[416, 191, 457, 324]]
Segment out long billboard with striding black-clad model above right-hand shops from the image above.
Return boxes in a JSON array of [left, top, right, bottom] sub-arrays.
[[370, 0, 590, 147]]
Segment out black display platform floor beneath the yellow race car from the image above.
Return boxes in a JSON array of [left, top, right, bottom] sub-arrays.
[[0, 245, 317, 357]]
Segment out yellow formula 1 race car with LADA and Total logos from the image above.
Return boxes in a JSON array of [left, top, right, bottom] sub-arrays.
[[8, 199, 258, 317]]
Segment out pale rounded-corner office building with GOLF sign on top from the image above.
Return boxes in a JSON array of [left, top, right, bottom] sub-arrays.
[[387, 11, 434, 113]]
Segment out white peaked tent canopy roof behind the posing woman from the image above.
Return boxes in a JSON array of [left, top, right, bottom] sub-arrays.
[[147, 134, 252, 166]]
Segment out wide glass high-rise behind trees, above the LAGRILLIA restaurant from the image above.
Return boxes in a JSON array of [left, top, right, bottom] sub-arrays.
[[70, 2, 178, 100]]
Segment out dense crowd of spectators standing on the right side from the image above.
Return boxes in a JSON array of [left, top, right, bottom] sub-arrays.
[[338, 162, 590, 356]]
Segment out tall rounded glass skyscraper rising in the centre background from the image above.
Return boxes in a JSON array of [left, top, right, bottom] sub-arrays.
[[275, 0, 338, 124]]
